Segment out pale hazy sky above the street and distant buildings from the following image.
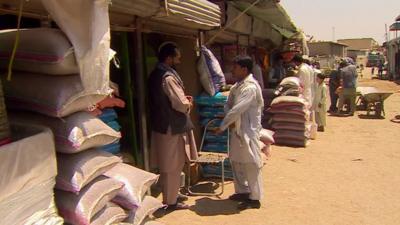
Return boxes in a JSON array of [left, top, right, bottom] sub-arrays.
[[280, 0, 400, 44]]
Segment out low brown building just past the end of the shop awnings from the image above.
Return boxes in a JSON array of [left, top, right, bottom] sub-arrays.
[[308, 41, 347, 69]]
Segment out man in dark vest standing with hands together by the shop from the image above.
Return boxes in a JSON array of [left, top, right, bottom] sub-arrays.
[[149, 43, 197, 210]]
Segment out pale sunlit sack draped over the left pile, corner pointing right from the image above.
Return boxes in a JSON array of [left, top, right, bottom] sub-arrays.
[[104, 163, 159, 209]]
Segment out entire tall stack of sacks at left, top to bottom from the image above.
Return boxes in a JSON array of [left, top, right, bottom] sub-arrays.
[[0, 28, 162, 225]]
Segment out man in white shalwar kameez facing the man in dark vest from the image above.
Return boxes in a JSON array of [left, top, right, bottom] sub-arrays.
[[216, 57, 264, 210]]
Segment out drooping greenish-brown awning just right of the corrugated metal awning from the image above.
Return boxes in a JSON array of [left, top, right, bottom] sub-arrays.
[[232, 0, 298, 38]]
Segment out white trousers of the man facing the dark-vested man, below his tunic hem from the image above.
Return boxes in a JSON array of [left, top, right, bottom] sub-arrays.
[[231, 161, 263, 200]]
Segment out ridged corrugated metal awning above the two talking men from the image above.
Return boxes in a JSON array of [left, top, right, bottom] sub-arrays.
[[151, 0, 221, 30]]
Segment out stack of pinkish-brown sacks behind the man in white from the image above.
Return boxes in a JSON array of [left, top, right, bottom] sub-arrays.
[[268, 96, 311, 147]]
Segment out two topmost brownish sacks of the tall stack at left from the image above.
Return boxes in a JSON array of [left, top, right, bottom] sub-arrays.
[[0, 28, 105, 117]]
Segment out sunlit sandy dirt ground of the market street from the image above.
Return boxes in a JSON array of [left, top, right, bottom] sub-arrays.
[[157, 69, 400, 225]]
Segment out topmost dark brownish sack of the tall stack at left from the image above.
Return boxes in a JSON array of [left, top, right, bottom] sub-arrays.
[[0, 28, 79, 75]]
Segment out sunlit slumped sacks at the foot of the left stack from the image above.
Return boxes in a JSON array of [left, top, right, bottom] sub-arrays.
[[55, 154, 163, 225]]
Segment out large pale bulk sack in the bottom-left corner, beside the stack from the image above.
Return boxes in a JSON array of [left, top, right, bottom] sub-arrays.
[[0, 123, 64, 225]]
